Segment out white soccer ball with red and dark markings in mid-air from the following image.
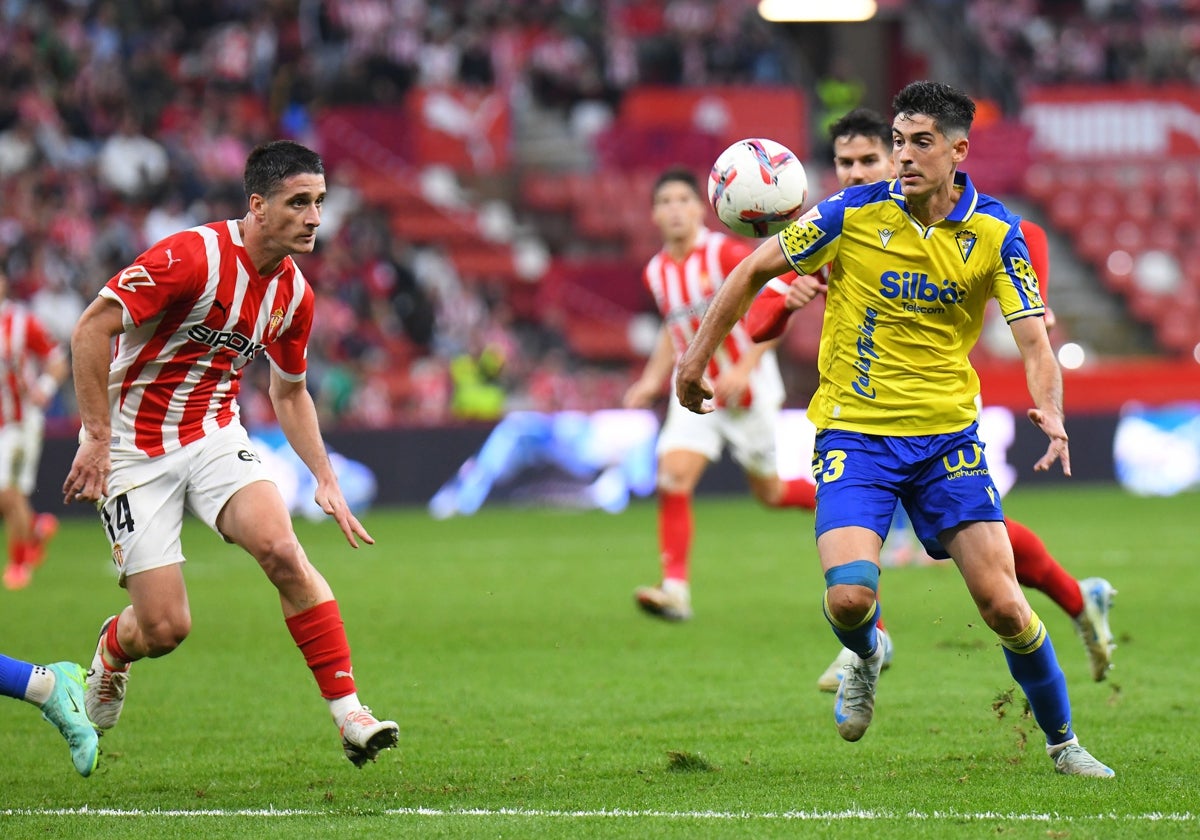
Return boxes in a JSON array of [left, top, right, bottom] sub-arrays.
[[708, 138, 809, 238]]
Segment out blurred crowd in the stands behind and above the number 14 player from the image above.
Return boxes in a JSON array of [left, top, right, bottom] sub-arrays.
[[0, 0, 796, 426]]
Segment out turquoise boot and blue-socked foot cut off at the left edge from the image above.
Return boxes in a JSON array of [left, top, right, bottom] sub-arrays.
[[0, 654, 100, 776]]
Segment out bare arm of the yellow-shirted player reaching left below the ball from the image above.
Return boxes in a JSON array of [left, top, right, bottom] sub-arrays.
[[676, 238, 791, 414]]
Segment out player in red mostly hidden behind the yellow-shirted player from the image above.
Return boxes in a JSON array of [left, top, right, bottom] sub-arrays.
[[745, 108, 1116, 691]]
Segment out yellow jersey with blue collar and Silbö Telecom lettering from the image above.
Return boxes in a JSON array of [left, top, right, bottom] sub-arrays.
[[778, 173, 1045, 436]]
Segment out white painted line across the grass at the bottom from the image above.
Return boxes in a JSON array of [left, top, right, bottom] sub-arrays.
[[0, 806, 1200, 822]]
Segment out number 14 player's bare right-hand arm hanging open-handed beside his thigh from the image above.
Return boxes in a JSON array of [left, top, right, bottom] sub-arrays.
[[271, 368, 374, 548]]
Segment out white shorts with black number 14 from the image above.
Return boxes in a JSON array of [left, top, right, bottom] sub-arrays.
[[96, 421, 270, 586]]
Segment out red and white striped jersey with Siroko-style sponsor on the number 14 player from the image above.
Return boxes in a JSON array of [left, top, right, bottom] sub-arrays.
[[100, 220, 313, 456]]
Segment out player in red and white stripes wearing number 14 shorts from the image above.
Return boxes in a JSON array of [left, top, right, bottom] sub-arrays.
[[62, 140, 398, 767]]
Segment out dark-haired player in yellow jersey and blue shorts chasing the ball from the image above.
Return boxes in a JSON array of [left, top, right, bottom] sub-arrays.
[[676, 82, 1114, 778]]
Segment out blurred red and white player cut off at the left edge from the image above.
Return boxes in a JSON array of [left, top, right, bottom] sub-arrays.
[[0, 271, 68, 589]]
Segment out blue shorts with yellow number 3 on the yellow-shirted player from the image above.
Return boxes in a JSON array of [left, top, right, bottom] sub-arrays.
[[812, 424, 1004, 559]]
